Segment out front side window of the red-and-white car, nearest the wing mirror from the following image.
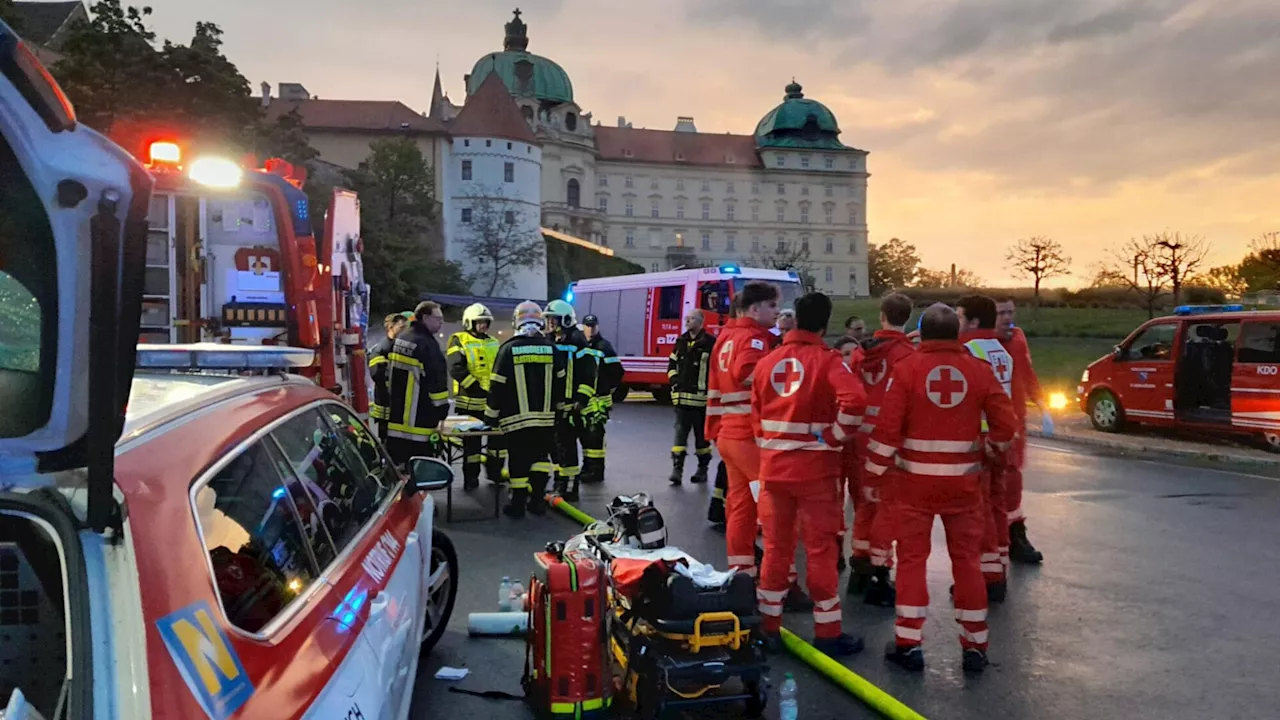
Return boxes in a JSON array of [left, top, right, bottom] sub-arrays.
[[271, 406, 387, 568]]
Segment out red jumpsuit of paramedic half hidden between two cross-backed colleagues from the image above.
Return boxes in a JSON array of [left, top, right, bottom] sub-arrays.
[[854, 331, 915, 568]]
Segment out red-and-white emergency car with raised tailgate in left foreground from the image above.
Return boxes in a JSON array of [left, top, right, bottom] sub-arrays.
[[0, 22, 457, 720]]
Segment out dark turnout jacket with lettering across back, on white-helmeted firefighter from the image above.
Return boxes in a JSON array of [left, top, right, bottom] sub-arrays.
[[484, 334, 567, 432]]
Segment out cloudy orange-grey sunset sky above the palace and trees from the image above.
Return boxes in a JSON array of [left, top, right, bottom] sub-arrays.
[[151, 0, 1280, 284]]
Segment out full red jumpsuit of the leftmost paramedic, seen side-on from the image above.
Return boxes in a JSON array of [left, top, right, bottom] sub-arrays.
[[707, 318, 773, 578]]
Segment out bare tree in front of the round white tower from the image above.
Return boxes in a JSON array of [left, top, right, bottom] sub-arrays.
[[462, 187, 547, 297]]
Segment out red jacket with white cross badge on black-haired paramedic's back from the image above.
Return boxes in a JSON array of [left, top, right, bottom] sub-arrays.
[[751, 329, 867, 482]]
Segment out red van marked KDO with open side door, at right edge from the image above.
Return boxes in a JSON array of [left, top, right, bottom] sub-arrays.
[[1076, 305, 1280, 452]]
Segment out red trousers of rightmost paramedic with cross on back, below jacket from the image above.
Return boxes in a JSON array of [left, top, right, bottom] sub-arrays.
[[893, 502, 991, 650]]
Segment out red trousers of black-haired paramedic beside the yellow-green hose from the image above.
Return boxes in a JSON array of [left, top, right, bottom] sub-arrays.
[[756, 477, 842, 638]]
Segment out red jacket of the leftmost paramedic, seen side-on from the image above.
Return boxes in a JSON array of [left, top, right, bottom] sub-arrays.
[[707, 318, 773, 442]]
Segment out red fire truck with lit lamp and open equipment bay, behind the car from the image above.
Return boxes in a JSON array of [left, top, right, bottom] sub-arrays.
[[138, 142, 369, 416]]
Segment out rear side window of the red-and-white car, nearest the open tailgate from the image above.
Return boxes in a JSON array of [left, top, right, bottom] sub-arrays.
[[196, 442, 320, 633]]
